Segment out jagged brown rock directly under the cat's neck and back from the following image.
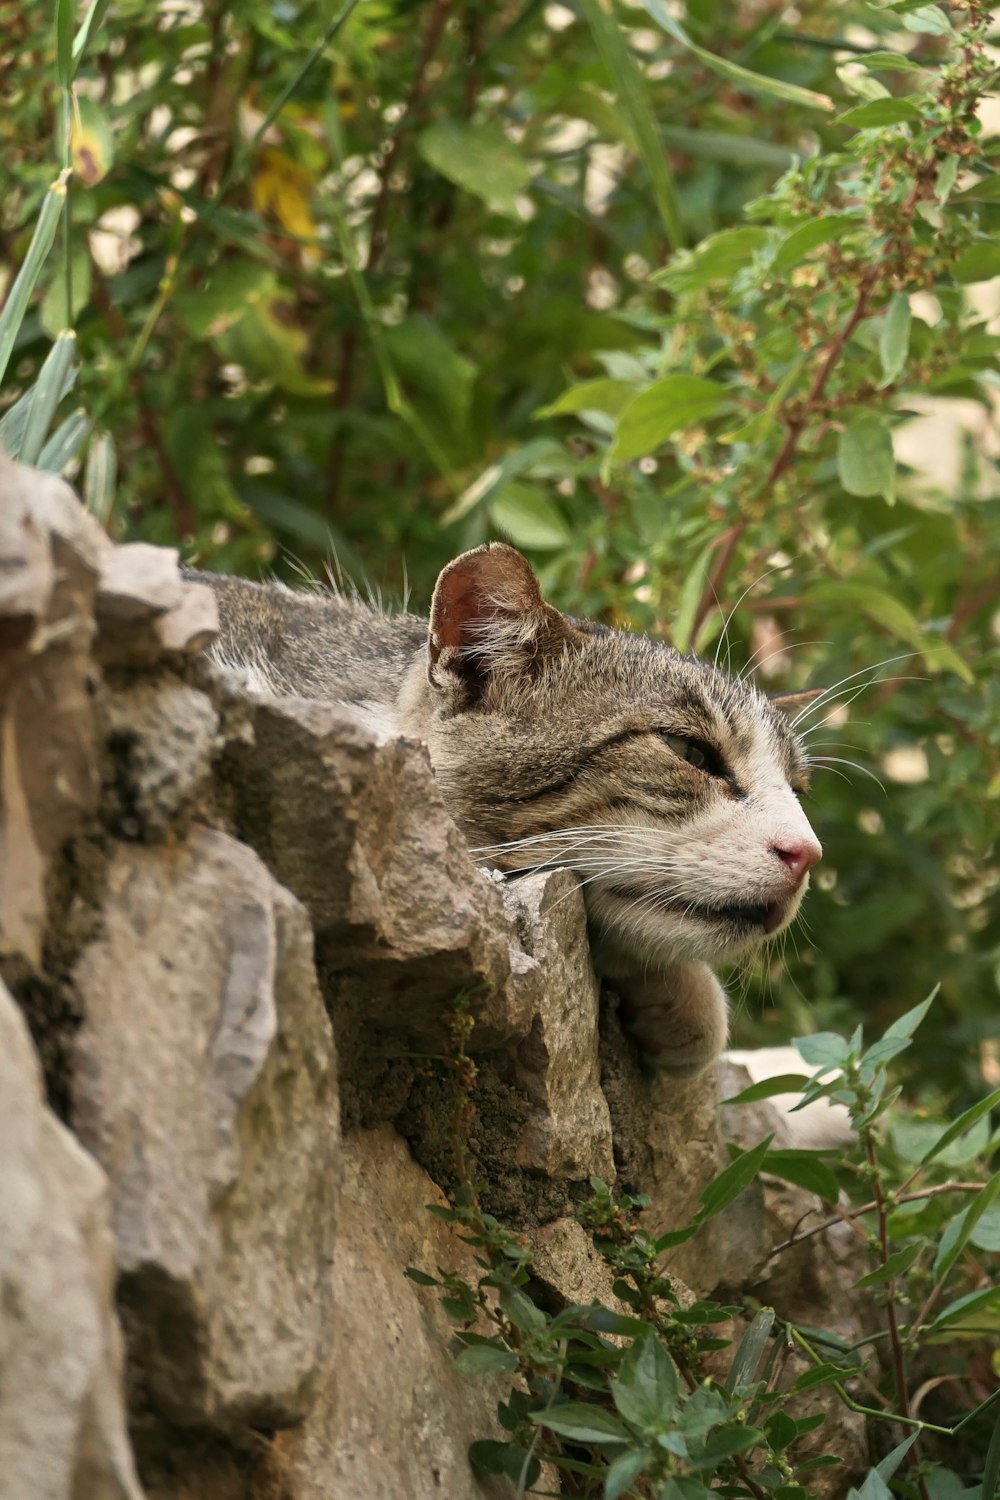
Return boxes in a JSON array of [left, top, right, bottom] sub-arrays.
[[232, 698, 510, 1043]]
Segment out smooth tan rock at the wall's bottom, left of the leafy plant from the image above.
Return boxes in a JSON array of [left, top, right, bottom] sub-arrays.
[[282, 1125, 511, 1500]]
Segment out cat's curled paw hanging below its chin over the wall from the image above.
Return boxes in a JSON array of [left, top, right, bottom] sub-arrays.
[[610, 963, 729, 1079]]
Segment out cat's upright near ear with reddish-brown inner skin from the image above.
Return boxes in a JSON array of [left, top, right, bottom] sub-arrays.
[[427, 542, 574, 704]]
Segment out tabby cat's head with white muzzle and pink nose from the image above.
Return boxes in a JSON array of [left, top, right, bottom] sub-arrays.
[[400, 543, 822, 972]]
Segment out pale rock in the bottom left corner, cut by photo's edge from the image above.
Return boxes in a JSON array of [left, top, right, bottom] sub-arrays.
[[0, 984, 139, 1500]]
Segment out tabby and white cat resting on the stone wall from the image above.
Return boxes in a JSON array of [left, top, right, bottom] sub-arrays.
[[198, 542, 822, 1077]]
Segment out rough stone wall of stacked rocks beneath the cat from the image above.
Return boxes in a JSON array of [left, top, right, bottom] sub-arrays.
[[0, 455, 858, 1500]]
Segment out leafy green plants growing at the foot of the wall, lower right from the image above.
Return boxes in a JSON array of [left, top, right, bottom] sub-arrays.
[[408, 998, 1000, 1500]]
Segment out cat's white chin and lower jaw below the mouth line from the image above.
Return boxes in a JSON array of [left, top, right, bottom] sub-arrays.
[[585, 878, 808, 974]]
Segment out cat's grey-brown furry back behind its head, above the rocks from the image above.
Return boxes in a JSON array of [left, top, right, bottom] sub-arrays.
[[190, 573, 427, 705]]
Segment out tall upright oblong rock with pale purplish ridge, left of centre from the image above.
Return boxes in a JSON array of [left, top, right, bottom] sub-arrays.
[[73, 828, 337, 1431]]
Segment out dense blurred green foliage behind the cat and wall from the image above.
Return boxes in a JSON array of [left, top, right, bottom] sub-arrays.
[[0, 0, 1000, 1103]]
